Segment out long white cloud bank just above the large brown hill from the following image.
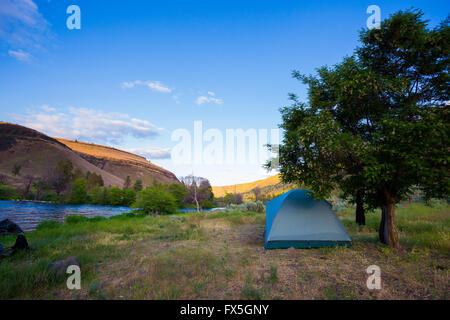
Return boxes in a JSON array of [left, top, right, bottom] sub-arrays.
[[12, 105, 163, 144]]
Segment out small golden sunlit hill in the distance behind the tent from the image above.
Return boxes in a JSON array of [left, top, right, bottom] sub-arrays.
[[212, 175, 295, 201]]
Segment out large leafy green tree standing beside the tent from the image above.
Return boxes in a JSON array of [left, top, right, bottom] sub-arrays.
[[267, 11, 450, 246]]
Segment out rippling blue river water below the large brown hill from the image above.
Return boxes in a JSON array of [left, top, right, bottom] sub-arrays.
[[0, 201, 131, 231]]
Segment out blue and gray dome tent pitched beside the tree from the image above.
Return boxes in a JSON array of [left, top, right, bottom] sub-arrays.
[[265, 189, 351, 249]]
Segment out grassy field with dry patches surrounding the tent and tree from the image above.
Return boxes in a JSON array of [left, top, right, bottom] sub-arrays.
[[0, 204, 450, 299]]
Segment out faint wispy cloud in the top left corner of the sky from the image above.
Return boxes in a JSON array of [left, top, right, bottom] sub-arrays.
[[0, 0, 52, 53]]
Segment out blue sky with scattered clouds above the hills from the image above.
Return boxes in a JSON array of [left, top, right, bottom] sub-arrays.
[[0, 0, 450, 186]]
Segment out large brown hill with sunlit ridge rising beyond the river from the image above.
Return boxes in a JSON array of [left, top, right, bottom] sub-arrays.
[[0, 122, 178, 187]]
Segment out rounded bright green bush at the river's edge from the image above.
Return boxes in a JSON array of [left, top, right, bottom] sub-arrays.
[[133, 186, 177, 214]]
